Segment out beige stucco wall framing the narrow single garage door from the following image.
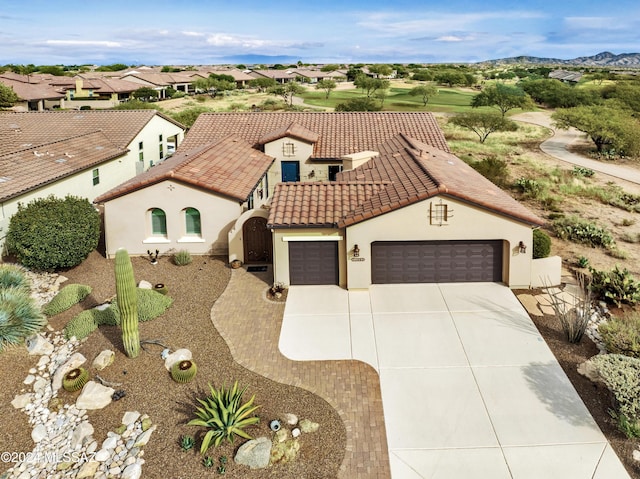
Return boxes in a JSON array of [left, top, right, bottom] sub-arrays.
[[273, 228, 347, 288]]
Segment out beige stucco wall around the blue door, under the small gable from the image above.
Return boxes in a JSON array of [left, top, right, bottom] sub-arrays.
[[264, 137, 342, 194]]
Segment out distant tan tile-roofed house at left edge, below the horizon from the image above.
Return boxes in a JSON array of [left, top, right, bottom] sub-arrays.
[[0, 72, 65, 111]]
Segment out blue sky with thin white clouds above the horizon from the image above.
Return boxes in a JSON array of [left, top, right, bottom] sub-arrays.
[[0, 0, 640, 65]]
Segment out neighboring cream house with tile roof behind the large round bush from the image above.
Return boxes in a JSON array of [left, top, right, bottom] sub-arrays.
[[0, 110, 185, 255]]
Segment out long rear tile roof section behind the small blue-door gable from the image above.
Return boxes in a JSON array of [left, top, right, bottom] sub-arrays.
[[180, 112, 449, 159]]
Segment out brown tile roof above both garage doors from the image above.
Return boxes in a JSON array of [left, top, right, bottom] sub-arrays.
[[268, 133, 543, 228]]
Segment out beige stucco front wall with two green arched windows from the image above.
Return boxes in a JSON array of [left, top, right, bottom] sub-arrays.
[[104, 181, 242, 256]]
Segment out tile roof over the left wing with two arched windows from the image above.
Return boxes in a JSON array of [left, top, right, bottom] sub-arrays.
[[95, 135, 273, 203]]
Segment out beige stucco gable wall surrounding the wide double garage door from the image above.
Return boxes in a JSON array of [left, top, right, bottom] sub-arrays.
[[341, 197, 533, 289]]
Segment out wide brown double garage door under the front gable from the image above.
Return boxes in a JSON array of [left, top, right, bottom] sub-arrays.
[[371, 240, 502, 284]]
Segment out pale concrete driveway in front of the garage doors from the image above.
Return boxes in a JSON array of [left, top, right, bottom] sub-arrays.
[[279, 283, 629, 479]]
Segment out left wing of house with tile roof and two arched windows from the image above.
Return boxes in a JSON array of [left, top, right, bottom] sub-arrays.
[[95, 135, 273, 258]]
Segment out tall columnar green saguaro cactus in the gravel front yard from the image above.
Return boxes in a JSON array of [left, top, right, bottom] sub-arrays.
[[116, 248, 140, 358]]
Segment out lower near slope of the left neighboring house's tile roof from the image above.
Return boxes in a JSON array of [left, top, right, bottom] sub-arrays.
[[0, 131, 127, 201]]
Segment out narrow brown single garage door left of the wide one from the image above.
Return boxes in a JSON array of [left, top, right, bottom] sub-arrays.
[[289, 241, 338, 284]]
